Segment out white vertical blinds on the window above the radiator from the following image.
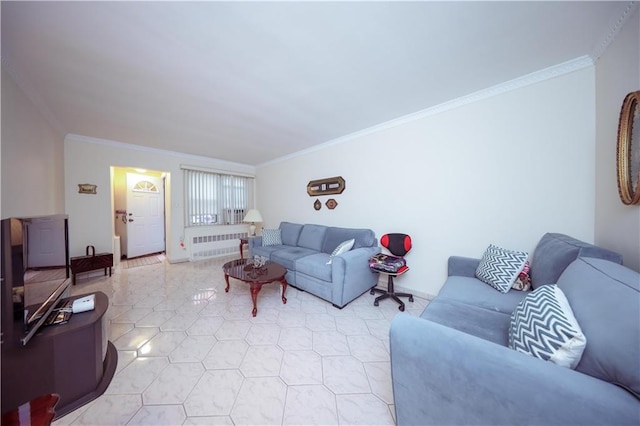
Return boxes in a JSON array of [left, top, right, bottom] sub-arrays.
[[184, 169, 254, 226]]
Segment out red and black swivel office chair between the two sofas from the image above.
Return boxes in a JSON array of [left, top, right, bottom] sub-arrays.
[[369, 234, 413, 311]]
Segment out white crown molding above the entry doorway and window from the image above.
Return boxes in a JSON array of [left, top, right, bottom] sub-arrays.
[[65, 133, 256, 176]]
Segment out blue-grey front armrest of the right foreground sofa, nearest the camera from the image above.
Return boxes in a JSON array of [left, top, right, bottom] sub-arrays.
[[389, 314, 640, 425]]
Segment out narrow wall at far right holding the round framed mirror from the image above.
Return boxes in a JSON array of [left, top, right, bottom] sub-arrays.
[[595, 8, 640, 271]]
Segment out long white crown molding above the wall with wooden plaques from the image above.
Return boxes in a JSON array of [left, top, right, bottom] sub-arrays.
[[256, 55, 594, 168]]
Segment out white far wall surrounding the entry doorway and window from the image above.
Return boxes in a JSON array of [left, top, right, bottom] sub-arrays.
[[64, 135, 255, 262]]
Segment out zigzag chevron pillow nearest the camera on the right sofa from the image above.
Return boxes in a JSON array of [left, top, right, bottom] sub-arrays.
[[509, 284, 587, 369]]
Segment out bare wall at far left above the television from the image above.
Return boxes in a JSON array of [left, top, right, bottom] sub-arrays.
[[1, 65, 64, 218]]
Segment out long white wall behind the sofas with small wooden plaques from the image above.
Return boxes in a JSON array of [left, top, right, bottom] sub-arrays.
[[256, 67, 595, 295]]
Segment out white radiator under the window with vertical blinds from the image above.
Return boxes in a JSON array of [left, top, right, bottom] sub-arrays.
[[185, 225, 249, 261]]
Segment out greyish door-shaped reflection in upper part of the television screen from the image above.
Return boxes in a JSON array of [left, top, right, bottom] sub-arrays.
[[27, 217, 67, 268]]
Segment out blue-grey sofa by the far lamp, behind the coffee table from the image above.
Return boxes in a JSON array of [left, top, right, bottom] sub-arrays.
[[249, 222, 380, 308]]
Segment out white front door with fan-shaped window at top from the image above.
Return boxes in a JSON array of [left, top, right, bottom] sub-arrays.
[[126, 173, 165, 258]]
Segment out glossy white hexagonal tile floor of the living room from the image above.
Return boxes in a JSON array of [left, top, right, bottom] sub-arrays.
[[54, 257, 427, 426]]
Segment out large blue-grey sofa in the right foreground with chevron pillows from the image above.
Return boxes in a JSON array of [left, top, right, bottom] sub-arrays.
[[390, 234, 640, 425]]
